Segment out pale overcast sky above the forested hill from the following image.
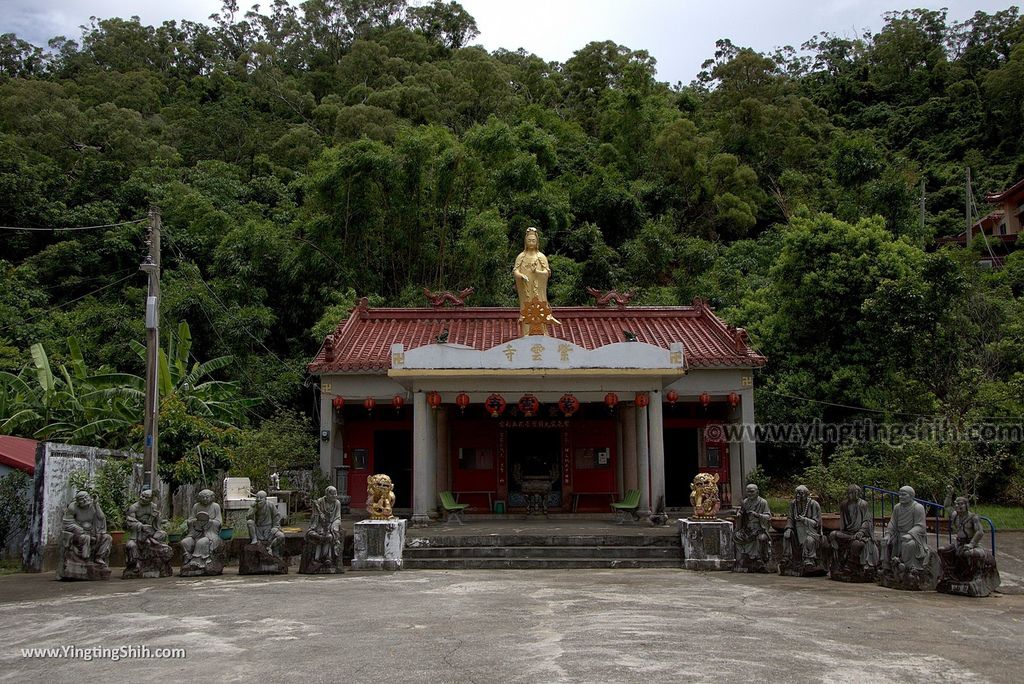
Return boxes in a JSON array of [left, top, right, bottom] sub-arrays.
[[0, 0, 1014, 83]]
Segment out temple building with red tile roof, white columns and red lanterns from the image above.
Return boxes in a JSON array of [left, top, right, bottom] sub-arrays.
[[309, 293, 766, 522]]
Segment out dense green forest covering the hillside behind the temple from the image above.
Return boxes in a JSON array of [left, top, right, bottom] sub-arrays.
[[0, 0, 1024, 502]]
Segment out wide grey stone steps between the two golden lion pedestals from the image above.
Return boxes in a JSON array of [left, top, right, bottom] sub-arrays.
[[402, 532, 683, 570]]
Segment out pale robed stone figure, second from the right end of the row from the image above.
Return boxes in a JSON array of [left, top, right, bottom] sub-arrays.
[[879, 486, 938, 591]]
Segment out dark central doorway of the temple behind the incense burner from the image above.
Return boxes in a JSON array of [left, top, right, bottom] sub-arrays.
[[508, 428, 562, 508]]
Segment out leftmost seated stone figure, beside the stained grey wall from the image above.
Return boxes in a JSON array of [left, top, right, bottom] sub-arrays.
[[56, 490, 112, 580]]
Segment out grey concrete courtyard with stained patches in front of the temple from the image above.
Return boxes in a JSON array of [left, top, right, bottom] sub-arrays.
[[0, 568, 1024, 683]]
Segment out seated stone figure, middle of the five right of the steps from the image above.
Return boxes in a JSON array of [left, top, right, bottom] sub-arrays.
[[828, 484, 879, 582]]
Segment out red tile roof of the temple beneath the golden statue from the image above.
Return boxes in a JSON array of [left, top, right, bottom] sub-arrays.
[[308, 300, 766, 374]]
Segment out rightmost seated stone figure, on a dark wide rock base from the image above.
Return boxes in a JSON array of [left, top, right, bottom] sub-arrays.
[[936, 497, 1000, 596]]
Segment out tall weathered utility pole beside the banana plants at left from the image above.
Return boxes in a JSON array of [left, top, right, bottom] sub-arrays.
[[139, 207, 160, 494]]
